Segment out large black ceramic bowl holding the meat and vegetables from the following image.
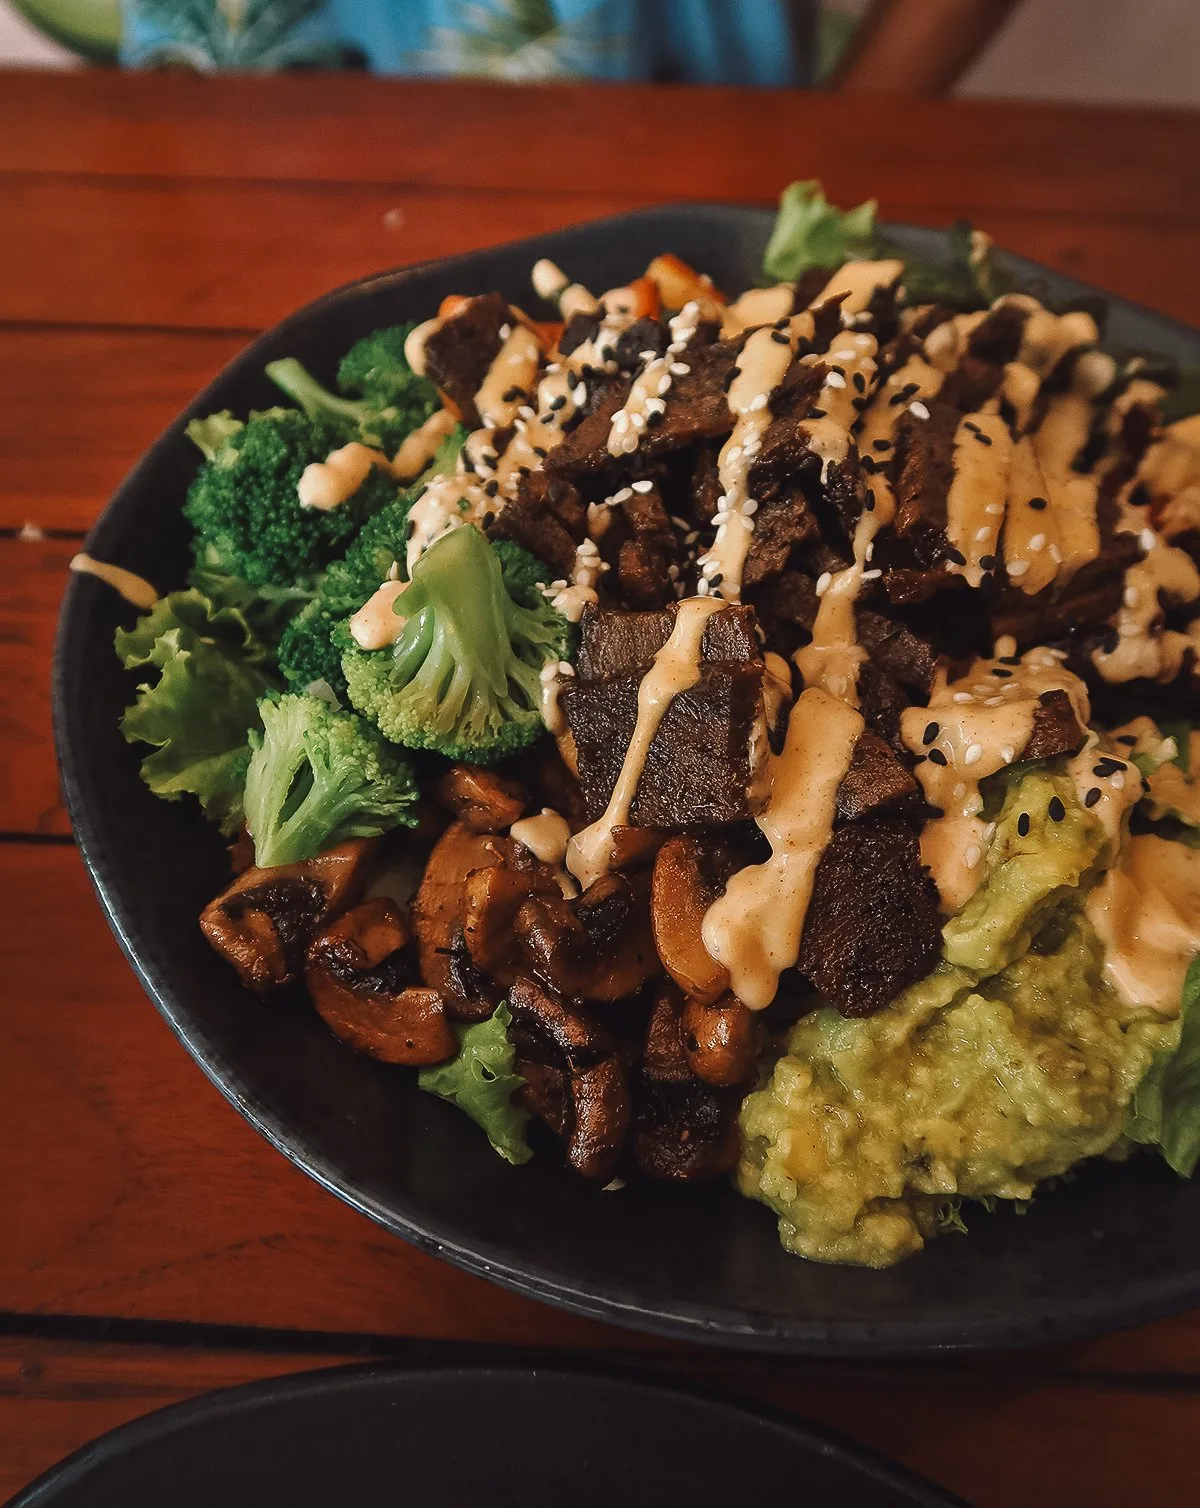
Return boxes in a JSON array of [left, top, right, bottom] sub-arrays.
[[54, 205, 1200, 1356]]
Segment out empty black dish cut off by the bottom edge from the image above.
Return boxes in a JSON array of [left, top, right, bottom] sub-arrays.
[[9, 1366, 954, 1508]]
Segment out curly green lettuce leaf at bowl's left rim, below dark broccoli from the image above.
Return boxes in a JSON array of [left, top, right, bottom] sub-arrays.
[[115, 588, 279, 835]]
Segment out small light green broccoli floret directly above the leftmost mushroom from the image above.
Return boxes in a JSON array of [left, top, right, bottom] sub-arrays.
[[246, 695, 418, 869]]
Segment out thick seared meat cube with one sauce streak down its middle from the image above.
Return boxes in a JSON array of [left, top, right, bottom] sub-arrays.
[[559, 606, 764, 828]]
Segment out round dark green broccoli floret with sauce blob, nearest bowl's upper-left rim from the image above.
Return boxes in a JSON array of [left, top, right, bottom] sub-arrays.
[[184, 409, 396, 587]]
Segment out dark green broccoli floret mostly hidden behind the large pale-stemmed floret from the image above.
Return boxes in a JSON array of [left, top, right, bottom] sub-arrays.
[[279, 427, 467, 701]]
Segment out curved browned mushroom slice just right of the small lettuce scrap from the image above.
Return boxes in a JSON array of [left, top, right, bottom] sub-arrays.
[[508, 977, 630, 1182]]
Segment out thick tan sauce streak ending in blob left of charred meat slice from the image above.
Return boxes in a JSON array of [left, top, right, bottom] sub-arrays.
[[701, 686, 864, 1010]]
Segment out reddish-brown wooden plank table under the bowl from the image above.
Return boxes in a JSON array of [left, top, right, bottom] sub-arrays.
[[0, 72, 1200, 1508]]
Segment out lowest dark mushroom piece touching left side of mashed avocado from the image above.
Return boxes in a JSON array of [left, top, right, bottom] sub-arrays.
[[632, 985, 742, 1184]]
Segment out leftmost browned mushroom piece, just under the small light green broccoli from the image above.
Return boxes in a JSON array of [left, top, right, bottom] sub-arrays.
[[201, 838, 377, 994]]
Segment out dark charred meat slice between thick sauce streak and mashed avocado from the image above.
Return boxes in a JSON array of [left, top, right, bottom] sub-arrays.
[[796, 817, 942, 1016]]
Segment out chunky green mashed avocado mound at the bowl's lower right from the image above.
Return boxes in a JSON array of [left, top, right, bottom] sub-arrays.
[[739, 769, 1179, 1267]]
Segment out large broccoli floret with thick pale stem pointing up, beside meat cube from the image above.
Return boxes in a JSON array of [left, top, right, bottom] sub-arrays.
[[342, 525, 571, 765]]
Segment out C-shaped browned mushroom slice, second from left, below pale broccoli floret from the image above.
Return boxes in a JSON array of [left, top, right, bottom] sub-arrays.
[[305, 896, 458, 1068]]
